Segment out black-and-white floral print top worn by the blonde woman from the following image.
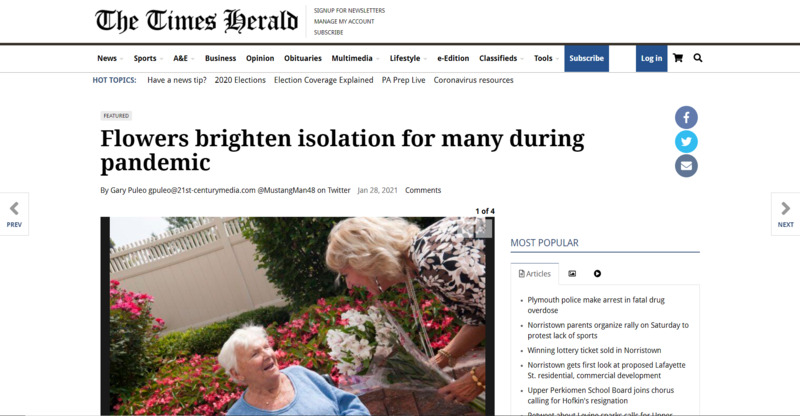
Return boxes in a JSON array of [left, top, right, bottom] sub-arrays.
[[409, 218, 486, 325]]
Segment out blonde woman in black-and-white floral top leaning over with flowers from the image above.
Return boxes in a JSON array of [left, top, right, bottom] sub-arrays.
[[325, 218, 486, 403]]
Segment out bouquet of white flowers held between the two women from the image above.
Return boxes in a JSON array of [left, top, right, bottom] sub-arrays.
[[327, 303, 486, 413]]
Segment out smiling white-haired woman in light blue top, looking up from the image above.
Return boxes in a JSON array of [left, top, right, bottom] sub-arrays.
[[217, 326, 369, 415]]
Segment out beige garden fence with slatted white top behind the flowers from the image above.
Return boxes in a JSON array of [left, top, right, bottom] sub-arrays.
[[110, 218, 286, 332]]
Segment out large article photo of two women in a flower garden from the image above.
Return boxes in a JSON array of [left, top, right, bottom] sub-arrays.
[[101, 217, 494, 415]]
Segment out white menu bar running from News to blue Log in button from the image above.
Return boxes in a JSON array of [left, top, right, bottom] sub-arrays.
[[2, 45, 800, 73]]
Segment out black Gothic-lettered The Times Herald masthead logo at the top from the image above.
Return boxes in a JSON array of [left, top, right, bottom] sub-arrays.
[[95, 9, 298, 33]]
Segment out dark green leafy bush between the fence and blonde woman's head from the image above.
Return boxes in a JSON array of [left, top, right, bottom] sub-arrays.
[[244, 217, 438, 309]]
